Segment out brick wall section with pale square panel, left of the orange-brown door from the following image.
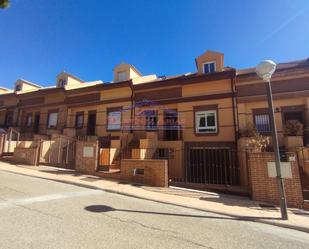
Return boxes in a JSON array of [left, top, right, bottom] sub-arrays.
[[75, 141, 99, 175]]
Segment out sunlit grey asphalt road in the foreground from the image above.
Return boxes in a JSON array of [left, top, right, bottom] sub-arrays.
[[0, 170, 309, 249]]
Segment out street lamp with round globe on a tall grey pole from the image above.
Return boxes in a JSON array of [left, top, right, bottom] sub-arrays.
[[256, 60, 288, 220]]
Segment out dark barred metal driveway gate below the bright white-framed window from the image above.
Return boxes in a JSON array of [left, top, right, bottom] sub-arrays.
[[185, 147, 239, 185]]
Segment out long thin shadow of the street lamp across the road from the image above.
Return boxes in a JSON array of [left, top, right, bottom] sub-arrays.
[[84, 205, 281, 221]]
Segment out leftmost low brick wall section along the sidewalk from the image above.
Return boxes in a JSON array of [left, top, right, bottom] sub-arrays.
[[13, 147, 39, 165]]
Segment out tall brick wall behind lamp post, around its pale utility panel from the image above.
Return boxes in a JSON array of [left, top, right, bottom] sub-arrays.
[[248, 153, 303, 208]]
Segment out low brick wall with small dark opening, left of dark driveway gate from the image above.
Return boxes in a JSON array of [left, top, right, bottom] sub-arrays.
[[121, 159, 168, 187]]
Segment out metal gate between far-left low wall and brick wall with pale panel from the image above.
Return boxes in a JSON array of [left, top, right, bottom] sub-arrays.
[[39, 136, 76, 169]]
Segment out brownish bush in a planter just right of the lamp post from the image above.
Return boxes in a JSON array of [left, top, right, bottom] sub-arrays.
[[284, 120, 304, 148]]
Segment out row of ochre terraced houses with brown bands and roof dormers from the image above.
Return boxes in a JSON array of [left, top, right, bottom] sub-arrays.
[[0, 51, 309, 208]]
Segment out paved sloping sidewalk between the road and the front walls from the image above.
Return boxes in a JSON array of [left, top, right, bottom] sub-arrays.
[[0, 161, 309, 233]]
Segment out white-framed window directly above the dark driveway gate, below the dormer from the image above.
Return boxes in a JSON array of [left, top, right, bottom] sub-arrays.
[[195, 110, 218, 133]]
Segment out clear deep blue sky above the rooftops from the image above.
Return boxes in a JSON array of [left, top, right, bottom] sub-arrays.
[[0, 0, 309, 88]]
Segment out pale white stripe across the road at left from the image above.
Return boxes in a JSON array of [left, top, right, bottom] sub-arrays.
[[0, 190, 103, 210]]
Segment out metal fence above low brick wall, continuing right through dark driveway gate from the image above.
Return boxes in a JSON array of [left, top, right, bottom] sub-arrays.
[[114, 147, 239, 185]]
